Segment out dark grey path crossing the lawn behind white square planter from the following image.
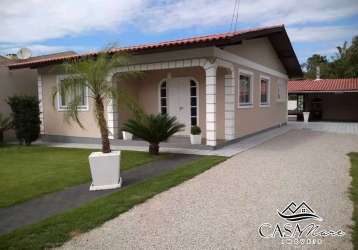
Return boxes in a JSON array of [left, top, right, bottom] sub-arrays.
[[0, 155, 200, 235]]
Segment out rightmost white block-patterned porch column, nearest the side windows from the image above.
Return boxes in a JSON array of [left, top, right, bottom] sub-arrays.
[[225, 73, 235, 140]]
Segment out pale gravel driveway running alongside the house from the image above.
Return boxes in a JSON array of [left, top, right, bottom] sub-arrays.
[[58, 130, 358, 249]]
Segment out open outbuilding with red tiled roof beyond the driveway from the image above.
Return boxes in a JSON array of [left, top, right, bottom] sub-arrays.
[[288, 78, 358, 122]]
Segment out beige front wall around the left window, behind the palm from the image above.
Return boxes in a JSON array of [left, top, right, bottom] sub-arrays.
[[39, 67, 100, 137]]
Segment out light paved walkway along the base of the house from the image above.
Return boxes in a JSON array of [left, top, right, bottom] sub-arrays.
[[37, 126, 291, 157]]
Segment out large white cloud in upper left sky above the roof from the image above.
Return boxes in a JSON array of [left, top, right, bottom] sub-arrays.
[[0, 0, 144, 43]]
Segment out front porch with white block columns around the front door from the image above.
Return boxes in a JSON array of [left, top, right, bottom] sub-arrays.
[[107, 59, 235, 149]]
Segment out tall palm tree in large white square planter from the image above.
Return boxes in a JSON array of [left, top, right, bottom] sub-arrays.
[[53, 50, 138, 190]]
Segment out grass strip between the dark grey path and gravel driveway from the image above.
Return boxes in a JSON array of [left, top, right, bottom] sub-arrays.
[[0, 156, 226, 249]]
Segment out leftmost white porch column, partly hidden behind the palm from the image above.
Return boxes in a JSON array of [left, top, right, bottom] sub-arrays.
[[107, 74, 119, 139]]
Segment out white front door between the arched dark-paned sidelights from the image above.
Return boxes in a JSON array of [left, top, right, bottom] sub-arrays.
[[167, 78, 191, 135]]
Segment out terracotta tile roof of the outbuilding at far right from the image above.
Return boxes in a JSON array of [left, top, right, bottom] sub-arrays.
[[288, 78, 358, 93]]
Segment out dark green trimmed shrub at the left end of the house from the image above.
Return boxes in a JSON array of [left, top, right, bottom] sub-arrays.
[[7, 96, 41, 145]]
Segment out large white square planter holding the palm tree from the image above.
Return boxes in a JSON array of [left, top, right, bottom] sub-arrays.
[[88, 151, 122, 191]]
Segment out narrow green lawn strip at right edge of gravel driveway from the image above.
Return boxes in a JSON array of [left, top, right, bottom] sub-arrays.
[[349, 153, 358, 249]]
